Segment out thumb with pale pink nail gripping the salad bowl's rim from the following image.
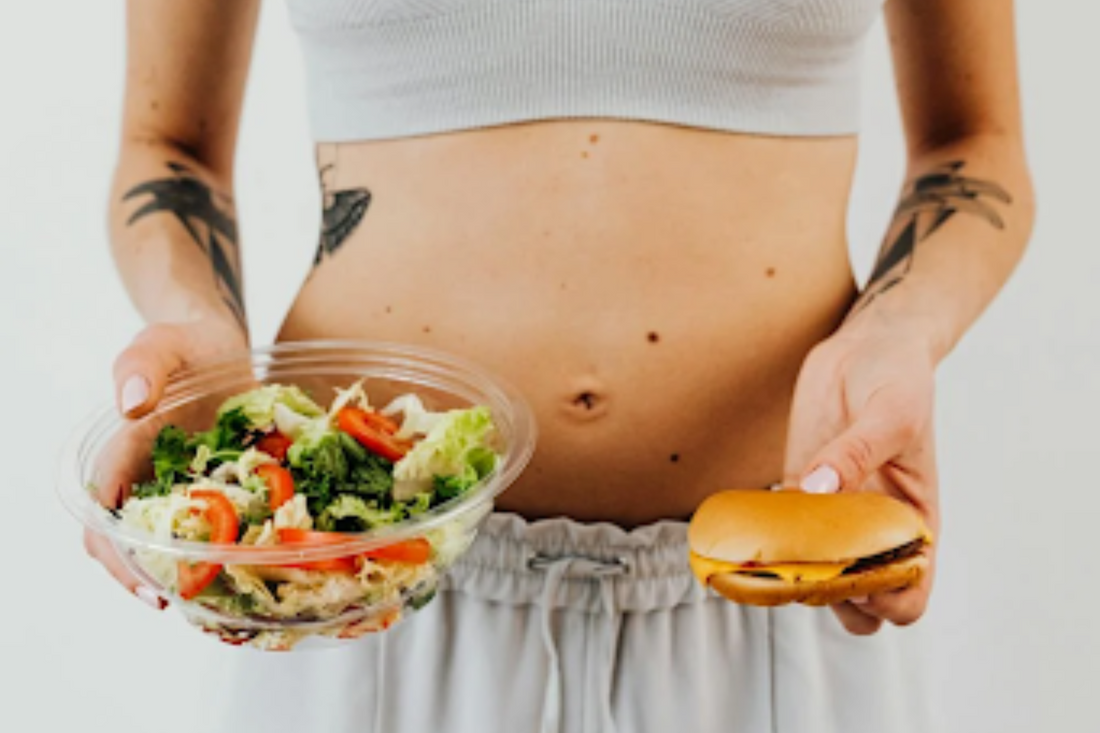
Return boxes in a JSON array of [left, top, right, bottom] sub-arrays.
[[114, 324, 186, 417]]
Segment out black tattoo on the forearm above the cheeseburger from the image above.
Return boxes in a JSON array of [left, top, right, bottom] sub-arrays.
[[853, 161, 1012, 314]]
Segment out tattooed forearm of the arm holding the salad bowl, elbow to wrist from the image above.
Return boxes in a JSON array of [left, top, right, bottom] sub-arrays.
[[109, 136, 248, 339]]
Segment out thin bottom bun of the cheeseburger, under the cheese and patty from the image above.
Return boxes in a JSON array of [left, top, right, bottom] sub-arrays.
[[710, 555, 928, 605]]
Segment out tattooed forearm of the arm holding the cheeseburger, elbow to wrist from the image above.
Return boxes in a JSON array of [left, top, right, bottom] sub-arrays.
[[843, 135, 1034, 363]]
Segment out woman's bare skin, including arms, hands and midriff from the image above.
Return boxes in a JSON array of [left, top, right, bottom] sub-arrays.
[[88, 0, 1033, 633]]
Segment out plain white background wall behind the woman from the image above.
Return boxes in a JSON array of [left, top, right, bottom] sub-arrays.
[[0, 0, 1100, 733]]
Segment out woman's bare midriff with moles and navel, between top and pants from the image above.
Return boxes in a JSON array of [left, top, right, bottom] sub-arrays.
[[279, 120, 856, 527]]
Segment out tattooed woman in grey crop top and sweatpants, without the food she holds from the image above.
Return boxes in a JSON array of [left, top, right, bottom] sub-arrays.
[[89, 0, 1032, 732]]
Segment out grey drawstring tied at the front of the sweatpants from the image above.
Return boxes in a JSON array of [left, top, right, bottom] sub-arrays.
[[527, 553, 627, 733]]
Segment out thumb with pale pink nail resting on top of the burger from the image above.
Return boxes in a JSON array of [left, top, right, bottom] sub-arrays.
[[800, 393, 919, 493]]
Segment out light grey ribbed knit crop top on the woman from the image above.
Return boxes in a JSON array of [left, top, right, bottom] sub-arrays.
[[287, 0, 883, 141]]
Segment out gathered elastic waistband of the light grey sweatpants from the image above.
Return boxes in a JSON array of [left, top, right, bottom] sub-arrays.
[[446, 513, 707, 613]]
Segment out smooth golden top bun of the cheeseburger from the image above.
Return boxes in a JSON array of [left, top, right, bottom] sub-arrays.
[[688, 489, 930, 565]]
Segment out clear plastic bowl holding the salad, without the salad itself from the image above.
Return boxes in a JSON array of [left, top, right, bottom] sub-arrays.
[[58, 341, 536, 649]]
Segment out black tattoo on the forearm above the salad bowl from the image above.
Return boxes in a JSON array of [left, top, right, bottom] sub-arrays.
[[122, 163, 245, 327]]
